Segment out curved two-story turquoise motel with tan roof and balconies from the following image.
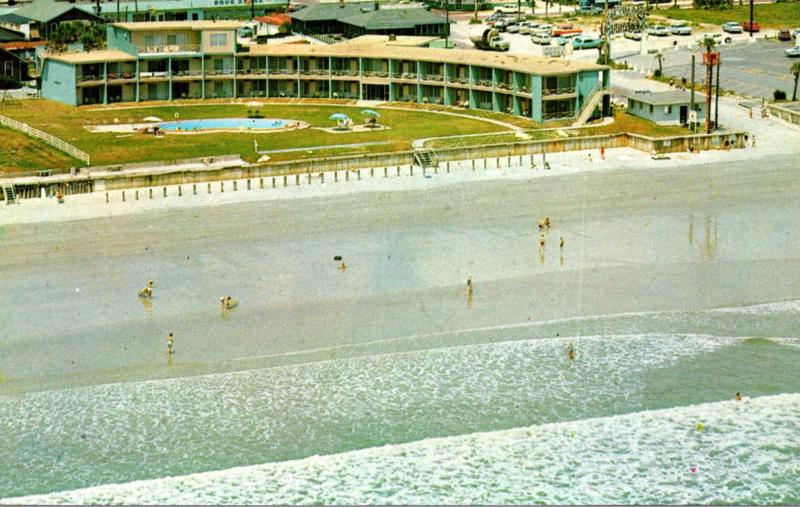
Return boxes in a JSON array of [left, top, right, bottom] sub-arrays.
[[42, 21, 610, 121]]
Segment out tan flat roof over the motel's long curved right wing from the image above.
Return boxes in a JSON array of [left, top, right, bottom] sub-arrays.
[[250, 36, 608, 75]]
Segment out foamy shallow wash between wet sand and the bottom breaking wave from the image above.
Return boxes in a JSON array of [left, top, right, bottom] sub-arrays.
[[0, 331, 741, 496]]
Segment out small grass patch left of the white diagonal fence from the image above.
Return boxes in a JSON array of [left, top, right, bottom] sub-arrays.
[[0, 127, 83, 173]]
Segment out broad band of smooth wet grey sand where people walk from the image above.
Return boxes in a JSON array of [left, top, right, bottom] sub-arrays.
[[0, 156, 800, 394]]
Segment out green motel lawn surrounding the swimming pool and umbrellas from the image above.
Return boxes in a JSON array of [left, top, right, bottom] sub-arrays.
[[4, 99, 508, 165]]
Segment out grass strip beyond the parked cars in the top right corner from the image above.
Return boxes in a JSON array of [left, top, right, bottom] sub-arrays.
[[652, 3, 800, 29]]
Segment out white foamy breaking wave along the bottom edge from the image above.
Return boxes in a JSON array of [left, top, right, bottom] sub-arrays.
[[7, 394, 800, 504]]
